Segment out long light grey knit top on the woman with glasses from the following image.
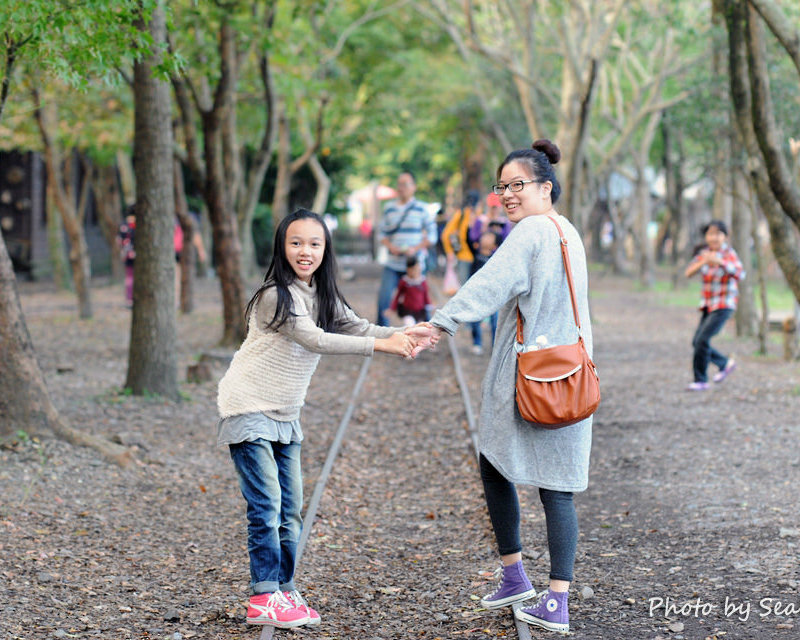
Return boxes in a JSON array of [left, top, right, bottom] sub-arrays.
[[431, 215, 592, 491]]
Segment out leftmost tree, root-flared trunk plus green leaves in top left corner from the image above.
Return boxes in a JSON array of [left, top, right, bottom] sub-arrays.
[[0, 0, 145, 464]]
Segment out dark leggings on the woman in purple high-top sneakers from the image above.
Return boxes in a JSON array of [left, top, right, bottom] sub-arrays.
[[480, 454, 578, 582]]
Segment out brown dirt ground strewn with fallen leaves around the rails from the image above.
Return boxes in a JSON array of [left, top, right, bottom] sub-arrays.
[[0, 268, 800, 640]]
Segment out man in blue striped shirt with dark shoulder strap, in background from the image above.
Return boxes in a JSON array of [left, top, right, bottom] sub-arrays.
[[377, 171, 436, 327]]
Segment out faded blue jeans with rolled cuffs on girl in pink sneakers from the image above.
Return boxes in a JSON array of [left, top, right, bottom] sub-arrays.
[[229, 439, 303, 595]]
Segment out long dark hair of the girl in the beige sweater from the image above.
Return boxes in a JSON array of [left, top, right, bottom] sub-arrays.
[[245, 209, 349, 332]]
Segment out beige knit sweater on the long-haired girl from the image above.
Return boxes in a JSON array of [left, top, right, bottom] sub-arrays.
[[217, 280, 400, 421]]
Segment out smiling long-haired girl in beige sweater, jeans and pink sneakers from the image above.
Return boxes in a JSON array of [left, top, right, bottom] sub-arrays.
[[212, 209, 429, 628]]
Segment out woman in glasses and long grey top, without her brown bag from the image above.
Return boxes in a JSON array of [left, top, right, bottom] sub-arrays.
[[431, 140, 593, 633]]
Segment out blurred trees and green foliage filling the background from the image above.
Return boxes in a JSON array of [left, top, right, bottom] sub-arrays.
[[0, 0, 800, 463]]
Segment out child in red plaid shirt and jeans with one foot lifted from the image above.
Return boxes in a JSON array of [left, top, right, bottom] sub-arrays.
[[686, 220, 745, 391]]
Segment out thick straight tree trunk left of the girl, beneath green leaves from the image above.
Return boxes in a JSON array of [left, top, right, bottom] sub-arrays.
[[125, 0, 178, 400]]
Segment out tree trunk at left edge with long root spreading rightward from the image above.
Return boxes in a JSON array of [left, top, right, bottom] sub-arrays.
[[0, 232, 133, 466]]
